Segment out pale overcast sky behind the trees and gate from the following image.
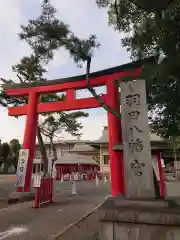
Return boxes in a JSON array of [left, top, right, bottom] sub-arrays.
[[0, 0, 130, 142]]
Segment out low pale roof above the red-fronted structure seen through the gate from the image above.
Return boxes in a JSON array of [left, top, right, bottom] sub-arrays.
[[55, 153, 97, 165]]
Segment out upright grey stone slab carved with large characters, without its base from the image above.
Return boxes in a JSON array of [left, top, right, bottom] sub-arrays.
[[121, 80, 155, 199]]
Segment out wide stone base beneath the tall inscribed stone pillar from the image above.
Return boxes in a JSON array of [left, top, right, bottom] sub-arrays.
[[99, 196, 180, 240]]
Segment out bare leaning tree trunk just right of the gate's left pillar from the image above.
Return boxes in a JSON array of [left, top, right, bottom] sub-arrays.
[[37, 126, 48, 174]]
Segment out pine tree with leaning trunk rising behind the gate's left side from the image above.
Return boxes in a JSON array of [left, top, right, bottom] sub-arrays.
[[0, 0, 99, 171]]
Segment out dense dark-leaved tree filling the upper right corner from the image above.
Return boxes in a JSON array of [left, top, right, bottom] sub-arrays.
[[96, 0, 180, 137]]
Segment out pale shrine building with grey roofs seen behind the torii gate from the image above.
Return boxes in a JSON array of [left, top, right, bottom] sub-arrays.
[[36, 126, 180, 176]]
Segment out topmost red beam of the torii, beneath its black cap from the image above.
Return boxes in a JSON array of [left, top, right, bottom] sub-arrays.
[[6, 70, 138, 96]]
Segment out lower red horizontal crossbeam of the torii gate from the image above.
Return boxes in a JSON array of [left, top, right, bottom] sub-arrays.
[[8, 94, 107, 116]]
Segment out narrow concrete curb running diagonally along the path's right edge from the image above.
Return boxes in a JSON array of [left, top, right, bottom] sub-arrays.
[[46, 195, 111, 240]]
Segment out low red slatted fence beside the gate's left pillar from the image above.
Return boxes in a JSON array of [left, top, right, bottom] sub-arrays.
[[34, 178, 53, 208]]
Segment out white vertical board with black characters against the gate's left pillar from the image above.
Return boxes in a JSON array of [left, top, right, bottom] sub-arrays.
[[16, 149, 29, 187]]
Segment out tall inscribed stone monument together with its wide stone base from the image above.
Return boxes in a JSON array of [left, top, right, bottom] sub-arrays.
[[100, 80, 180, 240]]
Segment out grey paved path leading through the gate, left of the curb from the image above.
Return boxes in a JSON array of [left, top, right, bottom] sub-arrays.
[[0, 181, 109, 240]]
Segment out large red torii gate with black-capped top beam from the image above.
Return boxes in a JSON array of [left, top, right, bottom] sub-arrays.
[[4, 61, 145, 196]]
